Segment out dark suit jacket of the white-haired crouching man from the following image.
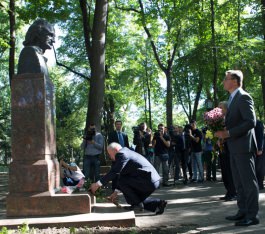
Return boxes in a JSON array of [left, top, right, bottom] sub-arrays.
[[100, 147, 160, 186]]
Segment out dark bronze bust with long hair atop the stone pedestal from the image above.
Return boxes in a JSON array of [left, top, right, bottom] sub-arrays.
[[17, 19, 55, 78]]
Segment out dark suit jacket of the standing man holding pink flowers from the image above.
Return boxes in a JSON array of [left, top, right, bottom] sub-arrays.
[[225, 88, 257, 154]]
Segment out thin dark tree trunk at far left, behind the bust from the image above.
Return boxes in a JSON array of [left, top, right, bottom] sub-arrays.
[[8, 0, 16, 85]]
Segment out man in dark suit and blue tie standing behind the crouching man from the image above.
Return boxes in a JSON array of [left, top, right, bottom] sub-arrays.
[[108, 120, 129, 148]]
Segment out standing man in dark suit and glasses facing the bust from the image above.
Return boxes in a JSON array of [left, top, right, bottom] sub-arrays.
[[215, 70, 259, 226]]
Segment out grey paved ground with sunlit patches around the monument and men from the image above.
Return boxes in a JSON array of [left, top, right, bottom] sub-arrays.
[[0, 172, 265, 234]]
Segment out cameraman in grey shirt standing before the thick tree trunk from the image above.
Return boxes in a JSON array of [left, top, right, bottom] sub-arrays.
[[81, 124, 104, 182]]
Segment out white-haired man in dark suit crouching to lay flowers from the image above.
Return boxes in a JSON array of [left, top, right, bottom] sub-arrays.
[[90, 143, 167, 214]]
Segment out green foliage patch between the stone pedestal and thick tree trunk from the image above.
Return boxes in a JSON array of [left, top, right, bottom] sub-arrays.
[[51, 69, 87, 163]]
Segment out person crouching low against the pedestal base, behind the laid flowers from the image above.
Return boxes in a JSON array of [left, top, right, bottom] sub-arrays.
[[60, 159, 85, 187]]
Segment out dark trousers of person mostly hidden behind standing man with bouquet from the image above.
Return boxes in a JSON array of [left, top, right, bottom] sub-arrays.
[[219, 151, 236, 197]]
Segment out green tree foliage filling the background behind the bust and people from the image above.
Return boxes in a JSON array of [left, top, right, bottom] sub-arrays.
[[0, 0, 265, 161]]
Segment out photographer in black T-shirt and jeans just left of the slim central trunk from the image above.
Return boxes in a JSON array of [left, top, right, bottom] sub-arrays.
[[153, 124, 170, 186]]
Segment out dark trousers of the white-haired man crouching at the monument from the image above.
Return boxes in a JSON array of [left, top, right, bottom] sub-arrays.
[[118, 174, 161, 212]]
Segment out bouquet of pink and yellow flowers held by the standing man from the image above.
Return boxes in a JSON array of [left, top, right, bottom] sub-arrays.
[[204, 107, 224, 132]]
